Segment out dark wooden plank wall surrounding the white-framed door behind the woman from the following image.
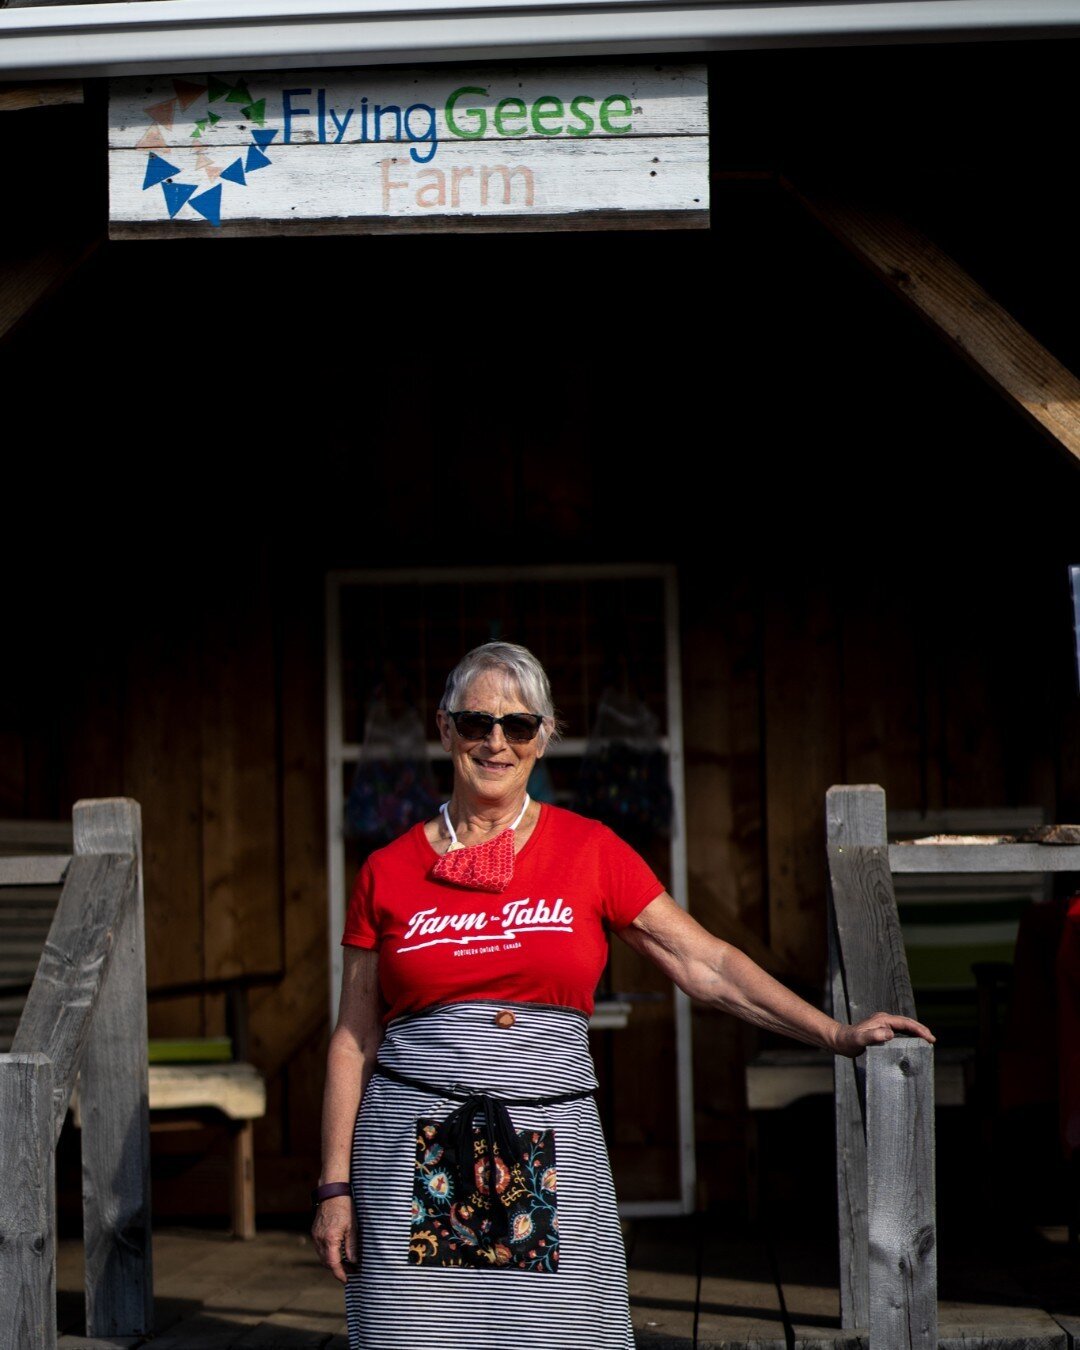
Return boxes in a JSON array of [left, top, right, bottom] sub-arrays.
[[0, 73, 1080, 1212]]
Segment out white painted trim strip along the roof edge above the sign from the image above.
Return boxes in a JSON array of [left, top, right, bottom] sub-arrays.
[[0, 0, 1080, 76]]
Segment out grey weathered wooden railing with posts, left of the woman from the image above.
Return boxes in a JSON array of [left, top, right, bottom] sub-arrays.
[[0, 798, 153, 1350]]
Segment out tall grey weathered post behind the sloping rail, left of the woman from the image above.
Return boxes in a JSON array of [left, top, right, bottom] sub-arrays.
[[74, 798, 154, 1337]]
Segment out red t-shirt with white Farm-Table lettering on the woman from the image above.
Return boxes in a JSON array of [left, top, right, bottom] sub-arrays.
[[342, 805, 664, 1022]]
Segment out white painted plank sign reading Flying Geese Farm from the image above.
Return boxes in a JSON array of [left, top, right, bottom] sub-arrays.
[[109, 65, 709, 238]]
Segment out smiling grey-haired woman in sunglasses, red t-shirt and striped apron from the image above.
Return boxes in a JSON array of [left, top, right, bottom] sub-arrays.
[[312, 643, 933, 1350]]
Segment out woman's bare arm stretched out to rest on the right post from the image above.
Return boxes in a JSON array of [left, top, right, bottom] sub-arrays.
[[618, 892, 934, 1057]]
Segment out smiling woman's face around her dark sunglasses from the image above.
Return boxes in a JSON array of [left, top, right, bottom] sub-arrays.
[[439, 671, 544, 803]]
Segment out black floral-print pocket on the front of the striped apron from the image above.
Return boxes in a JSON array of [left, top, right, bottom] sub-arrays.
[[409, 1119, 559, 1273]]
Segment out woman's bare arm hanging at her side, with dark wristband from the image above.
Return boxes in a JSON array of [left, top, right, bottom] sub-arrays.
[[312, 946, 382, 1284]]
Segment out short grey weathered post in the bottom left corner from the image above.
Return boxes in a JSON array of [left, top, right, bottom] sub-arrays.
[[0, 1053, 57, 1350]]
